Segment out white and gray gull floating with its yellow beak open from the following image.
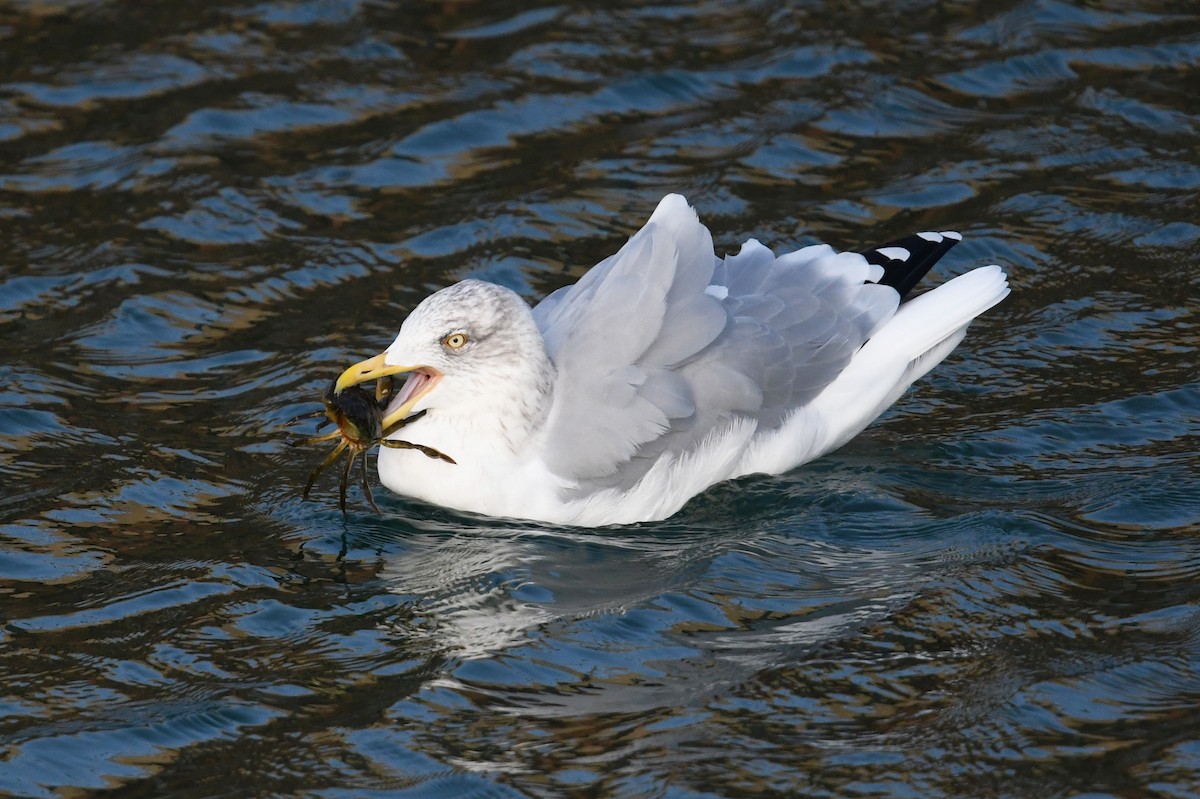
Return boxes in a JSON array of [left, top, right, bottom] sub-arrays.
[[335, 194, 1008, 527]]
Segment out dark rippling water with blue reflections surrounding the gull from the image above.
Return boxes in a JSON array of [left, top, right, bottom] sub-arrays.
[[0, 0, 1200, 799]]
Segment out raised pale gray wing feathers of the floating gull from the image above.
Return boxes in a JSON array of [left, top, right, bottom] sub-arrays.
[[534, 194, 900, 489]]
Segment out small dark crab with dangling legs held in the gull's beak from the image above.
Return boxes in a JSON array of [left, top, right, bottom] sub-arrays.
[[289, 378, 455, 515]]
